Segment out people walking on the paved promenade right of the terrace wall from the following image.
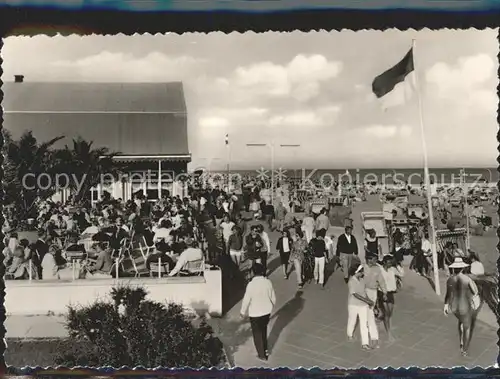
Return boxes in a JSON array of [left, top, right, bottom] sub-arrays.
[[240, 181, 498, 361]]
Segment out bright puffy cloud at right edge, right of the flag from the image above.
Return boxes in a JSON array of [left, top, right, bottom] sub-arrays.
[[425, 54, 498, 113]]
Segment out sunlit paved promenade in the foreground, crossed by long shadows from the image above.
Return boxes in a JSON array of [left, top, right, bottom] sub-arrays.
[[212, 197, 498, 369]]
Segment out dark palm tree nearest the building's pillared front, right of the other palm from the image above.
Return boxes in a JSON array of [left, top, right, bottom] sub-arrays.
[[55, 137, 120, 204]]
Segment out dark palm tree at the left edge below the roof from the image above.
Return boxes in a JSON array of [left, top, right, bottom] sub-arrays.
[[3, 131, 64, 221]]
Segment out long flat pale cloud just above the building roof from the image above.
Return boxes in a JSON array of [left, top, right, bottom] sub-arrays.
[[48, 51, 204, 82]]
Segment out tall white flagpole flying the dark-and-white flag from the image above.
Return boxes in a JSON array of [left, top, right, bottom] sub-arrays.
[[412, 40, 441, 296]]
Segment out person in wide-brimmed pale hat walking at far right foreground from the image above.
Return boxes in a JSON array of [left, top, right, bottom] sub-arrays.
[[443, 257, 481, 357]]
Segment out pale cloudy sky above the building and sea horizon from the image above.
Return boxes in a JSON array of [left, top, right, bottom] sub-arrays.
[[2, 29, 498, 169]]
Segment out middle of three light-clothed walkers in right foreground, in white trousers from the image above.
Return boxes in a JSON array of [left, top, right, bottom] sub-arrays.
[[365, 257, 387, 348]]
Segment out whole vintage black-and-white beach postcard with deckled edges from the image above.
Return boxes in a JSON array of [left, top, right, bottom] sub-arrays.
[[2, 29, 499, 369]]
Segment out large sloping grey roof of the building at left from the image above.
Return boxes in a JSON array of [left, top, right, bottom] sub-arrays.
[[2, 82, 189, 156]]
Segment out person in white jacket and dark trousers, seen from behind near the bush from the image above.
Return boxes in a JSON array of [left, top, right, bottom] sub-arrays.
[[240, 263, 276, 361]]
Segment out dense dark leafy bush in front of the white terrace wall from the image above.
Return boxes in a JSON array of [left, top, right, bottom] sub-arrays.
[[55, 287, 224, 368]]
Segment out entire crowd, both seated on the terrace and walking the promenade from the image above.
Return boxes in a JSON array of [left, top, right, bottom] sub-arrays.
[[4, 174, 496, 360]]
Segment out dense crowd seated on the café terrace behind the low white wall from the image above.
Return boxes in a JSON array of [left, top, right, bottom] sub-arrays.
[[4, 188, 254, 280]]
